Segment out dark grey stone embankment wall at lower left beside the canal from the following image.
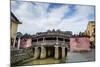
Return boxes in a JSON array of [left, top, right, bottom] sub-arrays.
[[11, 48, 33, 65]]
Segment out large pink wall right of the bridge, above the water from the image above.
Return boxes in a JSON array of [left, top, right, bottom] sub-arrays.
[[70, 37, 90, 51]]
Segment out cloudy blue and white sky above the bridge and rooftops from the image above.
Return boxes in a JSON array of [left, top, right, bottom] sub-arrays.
[[11, 1, 95, 35]]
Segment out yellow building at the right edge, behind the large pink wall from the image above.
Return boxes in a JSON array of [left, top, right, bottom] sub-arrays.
[[86, 21, 95, 47]]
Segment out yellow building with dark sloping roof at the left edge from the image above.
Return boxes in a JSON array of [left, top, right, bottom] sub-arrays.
[[10, 12, 21, 47]]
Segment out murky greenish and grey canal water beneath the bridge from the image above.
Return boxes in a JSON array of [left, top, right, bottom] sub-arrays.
[[23, 49, 95, 65]]
